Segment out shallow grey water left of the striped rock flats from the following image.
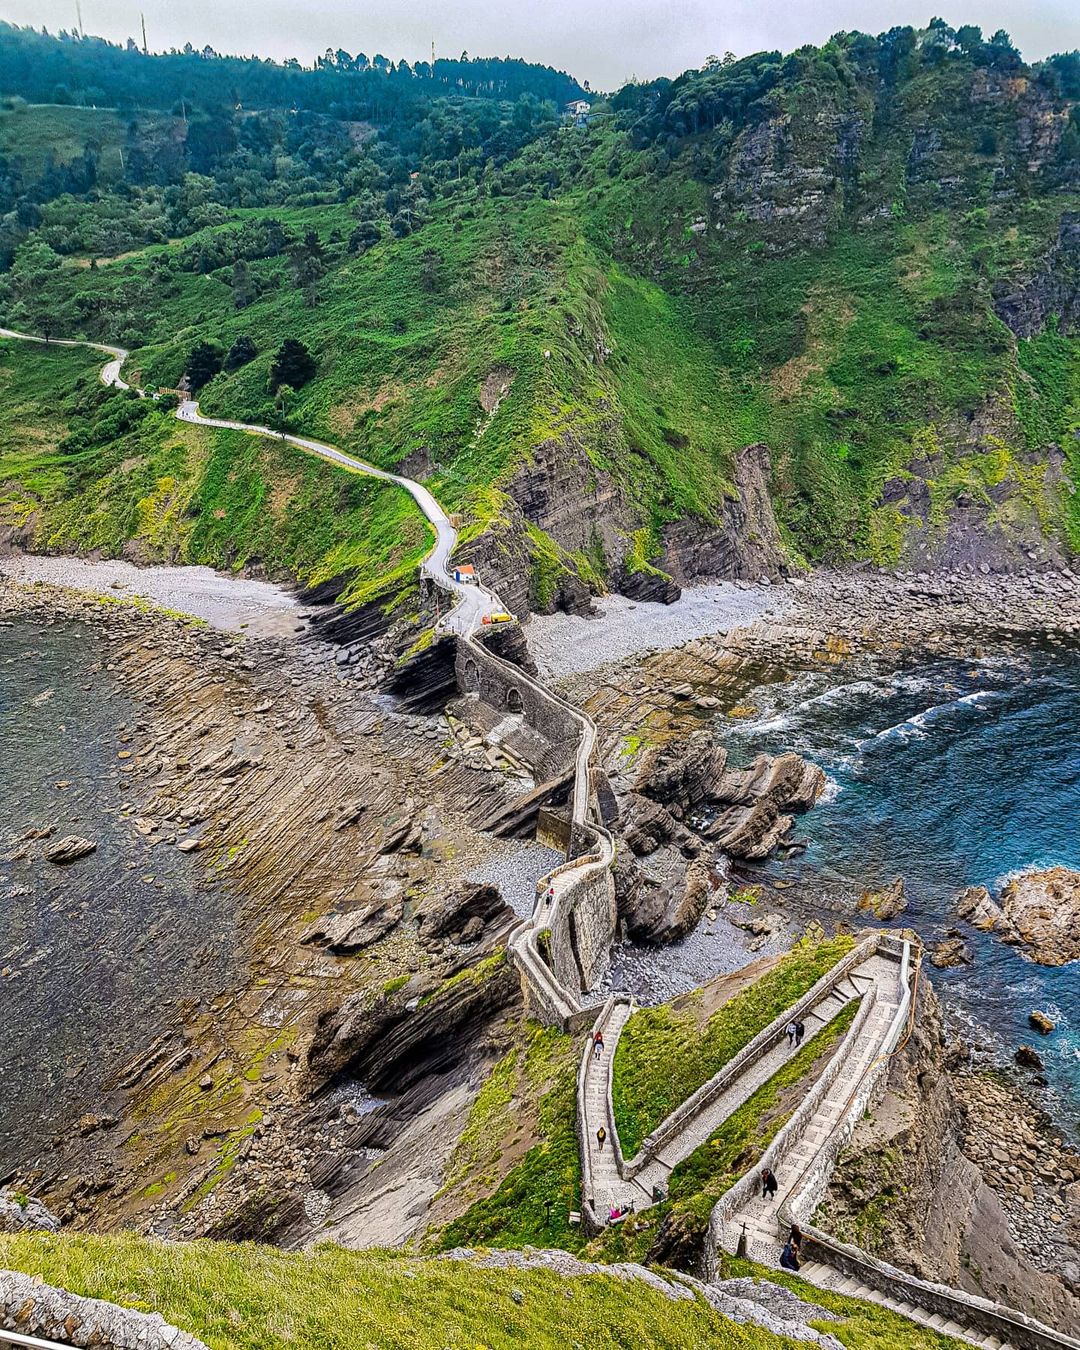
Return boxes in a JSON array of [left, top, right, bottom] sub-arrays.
[[0, 622, 239, 1176]]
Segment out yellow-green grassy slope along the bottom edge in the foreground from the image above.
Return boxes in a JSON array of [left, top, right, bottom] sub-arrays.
[[0, 1235, 972, 1350]]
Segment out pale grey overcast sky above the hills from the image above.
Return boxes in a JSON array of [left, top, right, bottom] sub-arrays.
[[8, 0, 1080, 89]]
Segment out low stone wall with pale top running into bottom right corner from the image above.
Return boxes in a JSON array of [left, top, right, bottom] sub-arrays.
[[802, 1224, 1080, 1350]]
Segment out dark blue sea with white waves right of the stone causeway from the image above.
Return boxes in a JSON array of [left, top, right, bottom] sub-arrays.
[[722, 649, 1080, 1127]]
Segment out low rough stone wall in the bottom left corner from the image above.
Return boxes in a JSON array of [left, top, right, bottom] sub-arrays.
[[0, 1270, 208, 1350]]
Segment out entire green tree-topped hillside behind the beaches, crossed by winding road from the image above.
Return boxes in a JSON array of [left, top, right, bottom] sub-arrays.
[[0, 20, 1080, 623]]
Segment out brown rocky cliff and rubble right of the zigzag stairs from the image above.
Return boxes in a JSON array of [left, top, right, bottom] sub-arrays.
[[815, 980, 1080, 1335]]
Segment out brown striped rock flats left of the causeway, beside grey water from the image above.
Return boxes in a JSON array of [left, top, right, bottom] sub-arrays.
[[0, 578, 540, 1238]]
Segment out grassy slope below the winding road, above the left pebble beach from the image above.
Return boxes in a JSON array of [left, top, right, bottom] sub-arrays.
[[0, 342, 429, 601]]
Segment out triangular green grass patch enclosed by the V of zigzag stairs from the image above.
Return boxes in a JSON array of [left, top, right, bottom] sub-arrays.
[[612, 936, 855, 1158]]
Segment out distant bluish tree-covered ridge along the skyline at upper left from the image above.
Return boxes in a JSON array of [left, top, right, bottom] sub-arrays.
[[0, 23, 586, 120]]
